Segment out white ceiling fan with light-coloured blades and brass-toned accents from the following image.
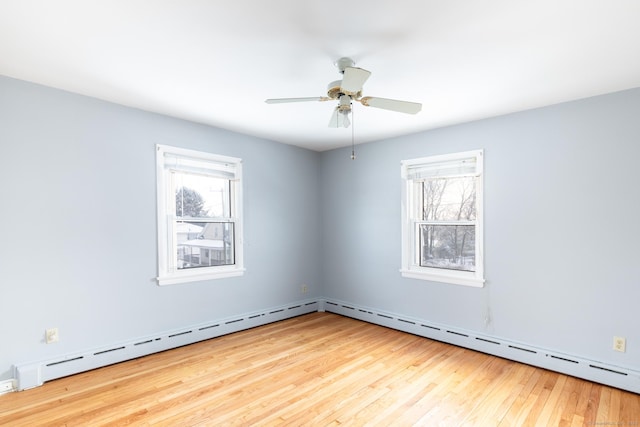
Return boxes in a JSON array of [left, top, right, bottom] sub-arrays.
[[265, 58, 422, 128]]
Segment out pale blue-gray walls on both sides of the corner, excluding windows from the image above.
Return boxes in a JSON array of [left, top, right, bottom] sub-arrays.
[[0, 72, 640, 380]]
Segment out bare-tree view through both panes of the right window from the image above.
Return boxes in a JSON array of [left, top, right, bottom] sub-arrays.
[[418, 176, 476, 271]]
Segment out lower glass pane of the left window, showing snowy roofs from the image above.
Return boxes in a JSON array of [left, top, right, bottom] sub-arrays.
[[176, 221, 235, 270]]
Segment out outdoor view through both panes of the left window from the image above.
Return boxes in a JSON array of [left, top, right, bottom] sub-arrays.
[[173, 172, 234, 269]]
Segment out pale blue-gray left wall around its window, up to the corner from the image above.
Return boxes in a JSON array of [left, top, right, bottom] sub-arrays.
[[0, 77, 320, 380]]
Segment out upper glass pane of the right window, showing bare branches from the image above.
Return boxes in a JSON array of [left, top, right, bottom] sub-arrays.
[[422, 177, 476, 221]]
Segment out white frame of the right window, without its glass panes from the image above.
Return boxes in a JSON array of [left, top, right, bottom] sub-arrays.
[[400, 150, 485, 288]]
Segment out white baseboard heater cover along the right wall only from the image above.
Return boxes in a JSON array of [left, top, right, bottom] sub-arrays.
[[321, 299, 640, 394]]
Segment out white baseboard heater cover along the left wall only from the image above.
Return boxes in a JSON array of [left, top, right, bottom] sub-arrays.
[[13, 300, 320, 390]]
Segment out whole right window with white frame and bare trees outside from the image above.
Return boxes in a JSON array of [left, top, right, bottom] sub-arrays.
[[401, 150, 484, 287]]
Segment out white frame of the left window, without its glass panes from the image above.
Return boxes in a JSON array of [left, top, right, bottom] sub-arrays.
[[156, 145, 245, 285]]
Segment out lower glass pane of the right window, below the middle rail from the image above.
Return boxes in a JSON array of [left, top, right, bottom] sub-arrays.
[[418, 224, 476, 271]]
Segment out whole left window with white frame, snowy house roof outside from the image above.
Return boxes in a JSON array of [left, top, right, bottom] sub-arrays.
[[156, 145, 244, 285]]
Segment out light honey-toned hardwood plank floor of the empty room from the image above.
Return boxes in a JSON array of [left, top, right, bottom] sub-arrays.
[[0, 313, 640, 426]]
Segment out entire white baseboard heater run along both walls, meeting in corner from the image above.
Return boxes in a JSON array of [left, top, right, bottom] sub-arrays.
[[10, 298, 640, 394]]
